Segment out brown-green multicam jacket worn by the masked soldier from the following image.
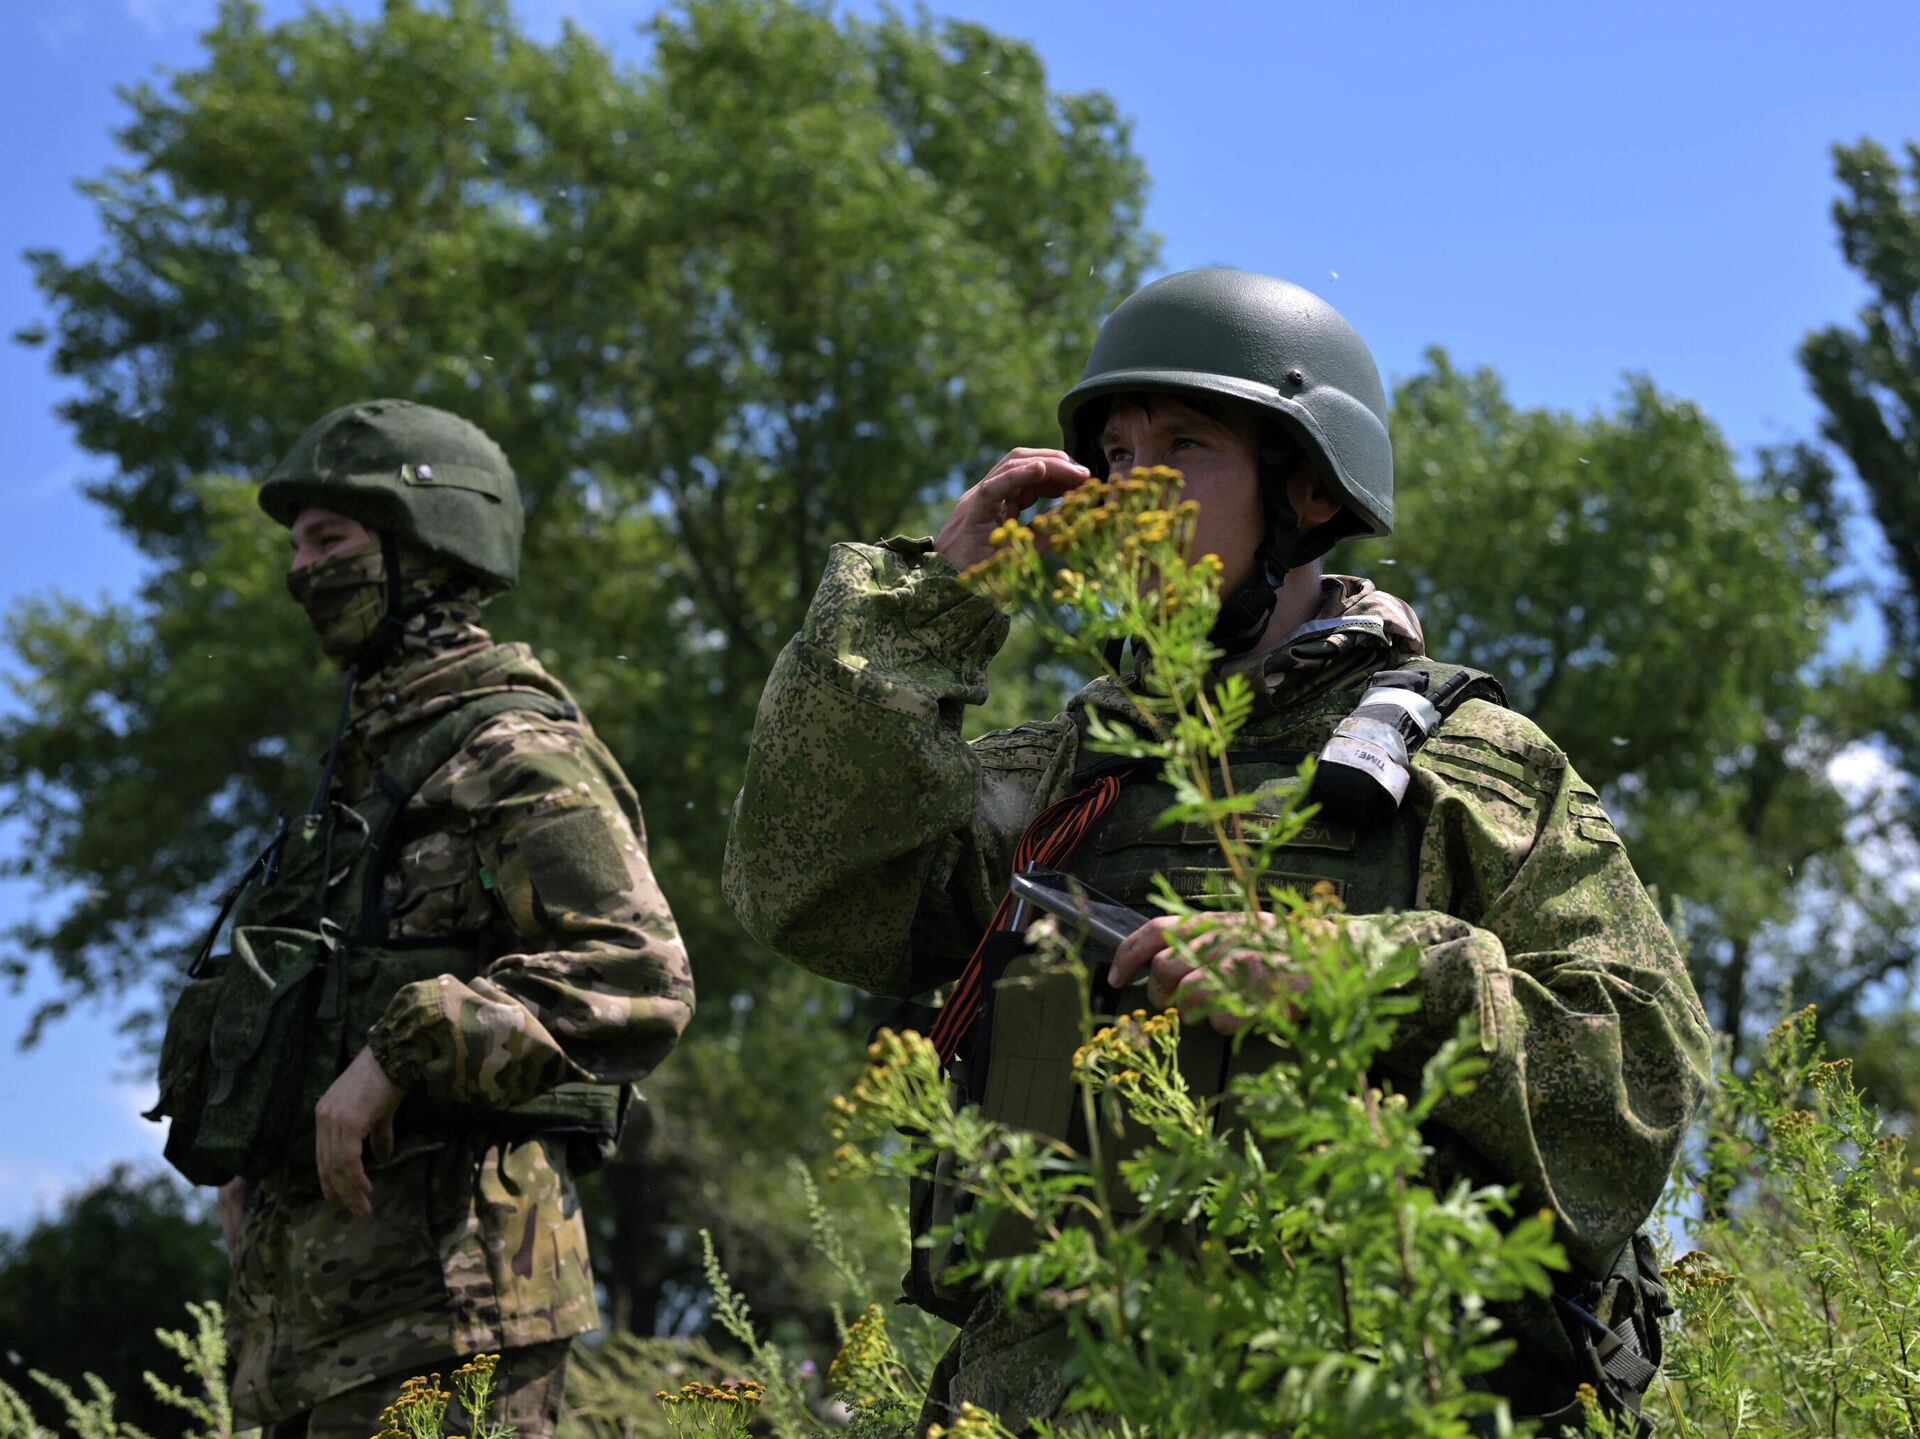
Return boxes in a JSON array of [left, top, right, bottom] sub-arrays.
[[228, 598, 693, 1422]]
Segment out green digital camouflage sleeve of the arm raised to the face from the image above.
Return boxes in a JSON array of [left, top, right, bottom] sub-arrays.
[[722, 540, 1073, 995]]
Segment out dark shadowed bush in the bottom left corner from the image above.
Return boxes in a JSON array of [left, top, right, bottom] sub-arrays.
[[0, 1164, 227, 1433]]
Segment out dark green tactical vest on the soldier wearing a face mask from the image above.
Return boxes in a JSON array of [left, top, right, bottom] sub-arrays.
[[148, 692, 628, 1183]]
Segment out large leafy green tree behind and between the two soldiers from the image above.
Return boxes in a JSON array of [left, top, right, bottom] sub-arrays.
[[0, 0, 1154, 1329]]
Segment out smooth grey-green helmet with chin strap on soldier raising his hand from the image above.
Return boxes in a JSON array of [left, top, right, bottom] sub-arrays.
[[1060, 267, 1394, 653]]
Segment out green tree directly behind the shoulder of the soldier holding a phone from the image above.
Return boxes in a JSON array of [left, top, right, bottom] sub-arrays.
[[1356, 350, 1910, 1045]]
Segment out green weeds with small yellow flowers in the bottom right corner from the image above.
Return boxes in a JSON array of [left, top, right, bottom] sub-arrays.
[[1663, 1007, 1920, 1439]]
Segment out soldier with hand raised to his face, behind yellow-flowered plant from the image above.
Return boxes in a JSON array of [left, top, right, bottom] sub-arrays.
[[724, 269, 1709, 1433]]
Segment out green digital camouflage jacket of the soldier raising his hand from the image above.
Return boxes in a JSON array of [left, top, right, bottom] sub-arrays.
[[724, 540, 1709, 1274]]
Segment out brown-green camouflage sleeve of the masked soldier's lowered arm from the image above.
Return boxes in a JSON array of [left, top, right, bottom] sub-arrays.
[[369, 713, 693, 1109]]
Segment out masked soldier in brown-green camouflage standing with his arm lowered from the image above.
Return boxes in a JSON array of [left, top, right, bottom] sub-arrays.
[[154, 400, 693, 1439]]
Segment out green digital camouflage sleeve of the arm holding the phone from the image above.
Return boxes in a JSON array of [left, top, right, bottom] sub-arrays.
[[1350, 701, 1711, 1270]]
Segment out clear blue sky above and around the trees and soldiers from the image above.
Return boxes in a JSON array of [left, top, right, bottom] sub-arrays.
[[0, 0, 1920, 1226]]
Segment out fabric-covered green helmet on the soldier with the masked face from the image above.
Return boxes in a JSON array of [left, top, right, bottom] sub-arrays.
[[259, 400, 526, 590]]
